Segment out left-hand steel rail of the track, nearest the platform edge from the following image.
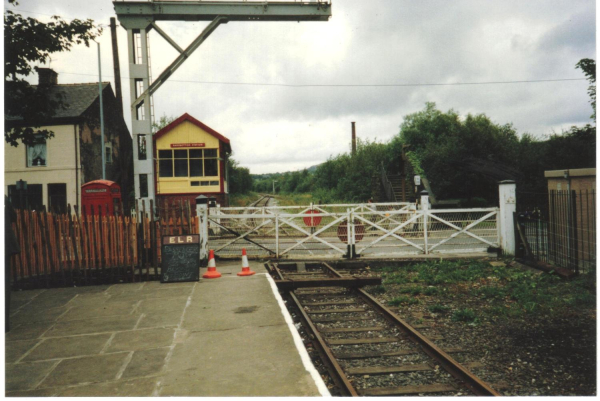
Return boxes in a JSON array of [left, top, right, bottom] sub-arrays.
[[265, 263, 359, 397]]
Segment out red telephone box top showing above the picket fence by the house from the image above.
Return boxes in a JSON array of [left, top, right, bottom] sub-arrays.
[[81, 180, 121, 214]]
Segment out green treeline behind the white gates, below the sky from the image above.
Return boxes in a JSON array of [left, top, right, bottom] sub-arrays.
[[244, 103, 596, 204]]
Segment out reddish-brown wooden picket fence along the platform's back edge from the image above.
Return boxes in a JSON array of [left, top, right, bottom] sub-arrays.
[[10, 199, 198, 289]]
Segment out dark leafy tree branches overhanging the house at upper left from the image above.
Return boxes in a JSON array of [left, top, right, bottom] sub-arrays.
[[4, 0, 102, 146]]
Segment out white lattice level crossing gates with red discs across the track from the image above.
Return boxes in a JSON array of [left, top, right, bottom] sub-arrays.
[[208, 203, 500, 259]]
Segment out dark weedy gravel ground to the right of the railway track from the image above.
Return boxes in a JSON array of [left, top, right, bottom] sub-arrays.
[[367, 260, 596, 396]]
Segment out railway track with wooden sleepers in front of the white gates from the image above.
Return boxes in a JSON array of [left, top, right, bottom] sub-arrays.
[[265, 263, 500, 396]]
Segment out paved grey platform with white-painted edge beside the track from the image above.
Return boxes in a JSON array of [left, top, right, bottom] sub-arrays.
[[5, 262, 328, 397]]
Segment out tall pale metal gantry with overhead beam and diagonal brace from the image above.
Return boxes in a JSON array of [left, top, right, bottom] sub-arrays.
[[113, 0, 332, 207]]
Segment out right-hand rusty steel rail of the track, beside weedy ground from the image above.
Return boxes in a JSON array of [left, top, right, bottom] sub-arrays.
[[323, 263, 500, 396]]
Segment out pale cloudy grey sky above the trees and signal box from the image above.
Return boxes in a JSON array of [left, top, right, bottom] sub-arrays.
[[4, 0, 596, 174]]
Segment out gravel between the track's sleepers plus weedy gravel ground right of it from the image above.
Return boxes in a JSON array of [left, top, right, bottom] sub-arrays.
[[282, 258, 596, 396]]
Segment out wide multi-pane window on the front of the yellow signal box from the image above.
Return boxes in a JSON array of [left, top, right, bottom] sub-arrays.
[[158, 149, 219, 178]]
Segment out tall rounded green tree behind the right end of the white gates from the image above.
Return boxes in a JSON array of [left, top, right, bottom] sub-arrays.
[[392, 103, 520, 202]]
